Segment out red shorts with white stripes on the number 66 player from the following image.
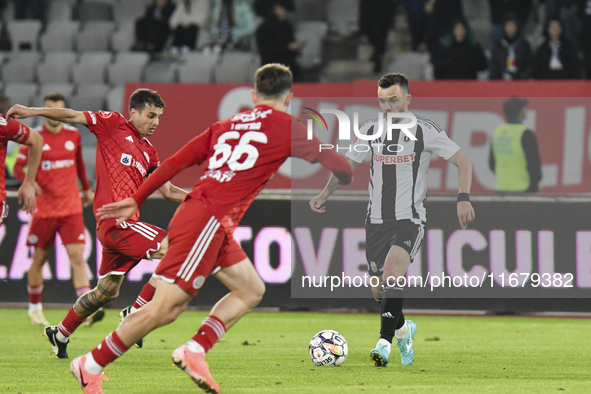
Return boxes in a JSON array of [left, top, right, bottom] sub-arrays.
[[154, 198, 247, 295]]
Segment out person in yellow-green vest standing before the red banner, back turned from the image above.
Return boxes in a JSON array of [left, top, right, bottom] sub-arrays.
[[489, 97, 542, 193]]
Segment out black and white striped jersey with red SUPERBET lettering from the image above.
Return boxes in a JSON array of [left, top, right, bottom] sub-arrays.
[[346, 116, 460, 224]]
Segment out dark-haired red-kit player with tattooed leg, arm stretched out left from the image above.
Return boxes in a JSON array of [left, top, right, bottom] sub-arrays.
[[8, 89, 187, 358]]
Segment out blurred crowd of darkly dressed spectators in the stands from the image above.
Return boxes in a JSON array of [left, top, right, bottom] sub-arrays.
[[0, 0, 591, 80]]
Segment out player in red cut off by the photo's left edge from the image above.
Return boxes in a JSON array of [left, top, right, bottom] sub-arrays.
[[0, 114, 43, 225]]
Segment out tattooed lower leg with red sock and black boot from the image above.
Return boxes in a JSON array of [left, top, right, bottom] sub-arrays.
[[45, 275, 124, 358]]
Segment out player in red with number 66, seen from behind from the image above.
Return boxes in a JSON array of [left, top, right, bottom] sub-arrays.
[[64, 64, 351, 393]]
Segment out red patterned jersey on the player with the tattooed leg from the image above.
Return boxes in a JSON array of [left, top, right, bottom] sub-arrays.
[[84, 111, 160, 224]]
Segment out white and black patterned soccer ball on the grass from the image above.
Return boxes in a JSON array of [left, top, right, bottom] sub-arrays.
[[310, 330, 349, 367]]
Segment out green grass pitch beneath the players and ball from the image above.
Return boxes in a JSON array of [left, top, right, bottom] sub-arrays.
[[0, 309, 591, 394]]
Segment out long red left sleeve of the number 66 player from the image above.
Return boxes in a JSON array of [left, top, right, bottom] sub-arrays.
[[132, 127, 212, 207]]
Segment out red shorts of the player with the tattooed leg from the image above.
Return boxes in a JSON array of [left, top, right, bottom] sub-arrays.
[[97, 219, 166, 278]]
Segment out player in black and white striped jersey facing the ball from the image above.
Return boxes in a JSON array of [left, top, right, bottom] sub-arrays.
[[310, 73, 475, 366]]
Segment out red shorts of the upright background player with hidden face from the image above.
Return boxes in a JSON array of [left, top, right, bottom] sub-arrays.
[[27, 215, 86, 249]]
